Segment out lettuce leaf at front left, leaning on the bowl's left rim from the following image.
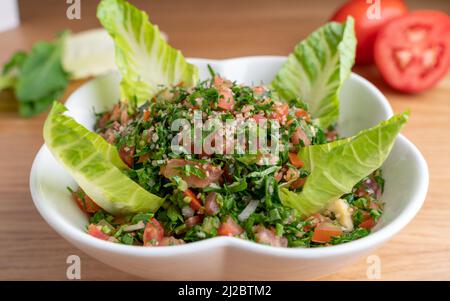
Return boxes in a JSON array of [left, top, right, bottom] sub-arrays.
[[44, 102, 164, 215]]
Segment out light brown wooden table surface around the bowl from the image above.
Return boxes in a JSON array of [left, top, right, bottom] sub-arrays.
[[0, 0, 450, 280]]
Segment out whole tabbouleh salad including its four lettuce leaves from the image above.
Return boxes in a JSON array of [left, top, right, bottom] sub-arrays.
[[44, 0, 409, 247]]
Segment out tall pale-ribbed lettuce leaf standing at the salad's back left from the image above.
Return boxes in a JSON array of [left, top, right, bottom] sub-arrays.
[[97, 0, 198, 105]]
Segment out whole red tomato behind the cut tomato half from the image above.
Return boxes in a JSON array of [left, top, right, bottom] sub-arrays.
[[331, 0, 408, 64]]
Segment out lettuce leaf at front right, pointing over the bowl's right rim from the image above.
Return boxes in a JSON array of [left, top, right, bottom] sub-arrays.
[[279, 113, 409, 216]]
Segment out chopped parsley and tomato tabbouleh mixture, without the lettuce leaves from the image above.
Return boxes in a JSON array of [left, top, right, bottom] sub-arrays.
[[73, 76, 383, 247]]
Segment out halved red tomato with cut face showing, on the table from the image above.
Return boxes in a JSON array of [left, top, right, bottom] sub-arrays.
[[375, 11, 450, 93]]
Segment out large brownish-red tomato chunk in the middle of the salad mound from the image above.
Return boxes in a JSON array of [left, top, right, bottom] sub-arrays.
[[161, 159, 223, 188]]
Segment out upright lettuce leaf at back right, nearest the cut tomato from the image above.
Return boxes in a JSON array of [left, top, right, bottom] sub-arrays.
[[272, 17, 356, 128]]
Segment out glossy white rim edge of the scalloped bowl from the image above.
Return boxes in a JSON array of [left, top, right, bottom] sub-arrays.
[[30, 56, 429, 259]]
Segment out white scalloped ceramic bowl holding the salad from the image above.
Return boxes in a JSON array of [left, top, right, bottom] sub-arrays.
[[30, 56, 428, 280]]
